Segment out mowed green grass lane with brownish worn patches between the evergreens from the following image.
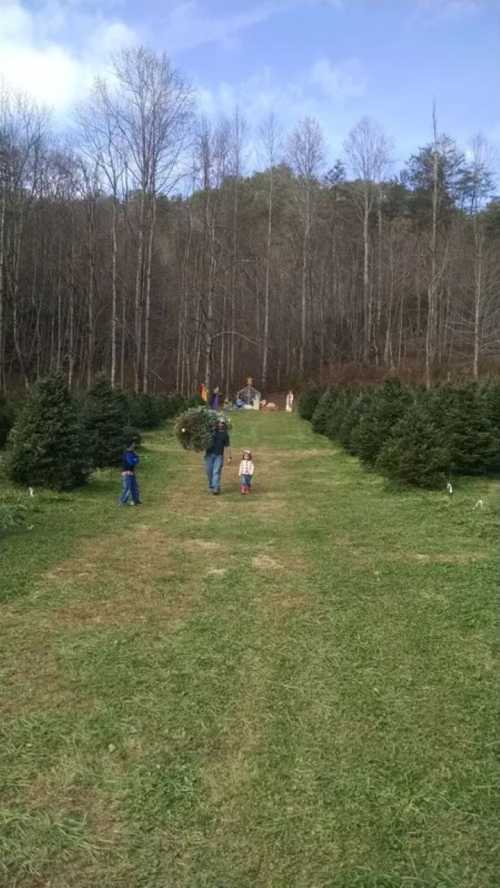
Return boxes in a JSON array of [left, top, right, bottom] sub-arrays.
[[0, 414, 498, 888]]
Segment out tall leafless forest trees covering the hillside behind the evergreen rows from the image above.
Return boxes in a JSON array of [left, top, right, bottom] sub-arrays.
[[0, 48, 500, 394]]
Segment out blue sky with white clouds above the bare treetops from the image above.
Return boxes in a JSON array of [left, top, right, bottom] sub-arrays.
[[0, 0, 500, 163]]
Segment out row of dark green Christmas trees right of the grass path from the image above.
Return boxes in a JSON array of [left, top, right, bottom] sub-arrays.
[[299, 379, 500, 488]]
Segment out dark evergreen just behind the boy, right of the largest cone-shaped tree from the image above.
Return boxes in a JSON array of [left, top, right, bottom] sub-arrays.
[[82, 377, 128, 468]]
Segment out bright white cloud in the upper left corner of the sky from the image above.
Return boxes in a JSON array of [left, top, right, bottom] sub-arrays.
[[0, 0, 137, 112]]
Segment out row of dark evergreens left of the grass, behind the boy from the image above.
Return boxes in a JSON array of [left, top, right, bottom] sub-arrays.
[[0, 373, 195, 490]]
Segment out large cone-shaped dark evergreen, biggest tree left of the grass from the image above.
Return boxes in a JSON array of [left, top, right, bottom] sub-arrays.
[[7, 373, 91, 490]]
